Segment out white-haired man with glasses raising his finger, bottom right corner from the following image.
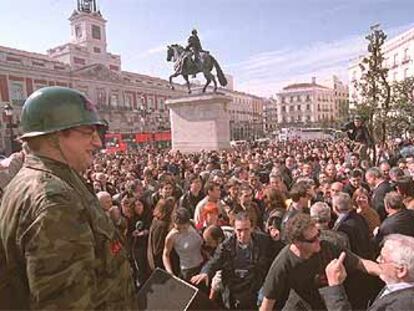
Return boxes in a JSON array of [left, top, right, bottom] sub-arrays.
[[319, 234, 414, 311]]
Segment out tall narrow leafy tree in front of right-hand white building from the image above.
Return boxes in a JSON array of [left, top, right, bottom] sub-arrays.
[[355, 25, 392, 147]]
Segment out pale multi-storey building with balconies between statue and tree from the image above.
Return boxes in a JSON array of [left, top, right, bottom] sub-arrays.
[[276, 76, 348, 127]]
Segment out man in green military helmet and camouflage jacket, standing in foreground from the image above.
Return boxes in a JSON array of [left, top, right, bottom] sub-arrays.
[[0, 87, 135, 310]]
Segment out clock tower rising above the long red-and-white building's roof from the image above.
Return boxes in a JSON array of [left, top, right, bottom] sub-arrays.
[[69, 0, 107, 54]]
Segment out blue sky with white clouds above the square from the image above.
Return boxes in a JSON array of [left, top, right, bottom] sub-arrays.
[[0, 0, 414, 97]]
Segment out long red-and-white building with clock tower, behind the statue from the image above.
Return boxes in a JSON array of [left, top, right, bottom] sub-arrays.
[[0, 0, 263, 154]]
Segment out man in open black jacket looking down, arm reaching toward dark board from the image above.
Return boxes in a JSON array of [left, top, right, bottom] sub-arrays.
[[191, 212, 272, 310]]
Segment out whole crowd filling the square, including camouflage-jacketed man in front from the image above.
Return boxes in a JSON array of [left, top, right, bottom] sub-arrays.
[[0, 89, 414, 310]]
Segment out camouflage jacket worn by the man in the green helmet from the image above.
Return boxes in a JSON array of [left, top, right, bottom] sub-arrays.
[[0, 155, 135, 310]]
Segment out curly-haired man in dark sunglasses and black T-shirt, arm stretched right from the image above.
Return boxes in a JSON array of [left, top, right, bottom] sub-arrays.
[[260, 213, 379, 311]]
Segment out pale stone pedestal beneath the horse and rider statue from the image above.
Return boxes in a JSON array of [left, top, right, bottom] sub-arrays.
[[165, 94, 232, 153]]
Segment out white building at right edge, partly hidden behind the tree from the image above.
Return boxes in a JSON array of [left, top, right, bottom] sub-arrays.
[[348, 27, 414, 109]]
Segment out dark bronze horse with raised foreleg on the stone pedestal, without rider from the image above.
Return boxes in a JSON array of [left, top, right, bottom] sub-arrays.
[[167, 44, 227, 94]]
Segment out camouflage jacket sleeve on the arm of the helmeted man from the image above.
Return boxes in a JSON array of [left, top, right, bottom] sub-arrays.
[[20, 196, 97, 309]]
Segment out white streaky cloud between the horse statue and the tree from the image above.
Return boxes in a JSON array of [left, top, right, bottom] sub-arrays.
[[230, 24, 413, 96]]
